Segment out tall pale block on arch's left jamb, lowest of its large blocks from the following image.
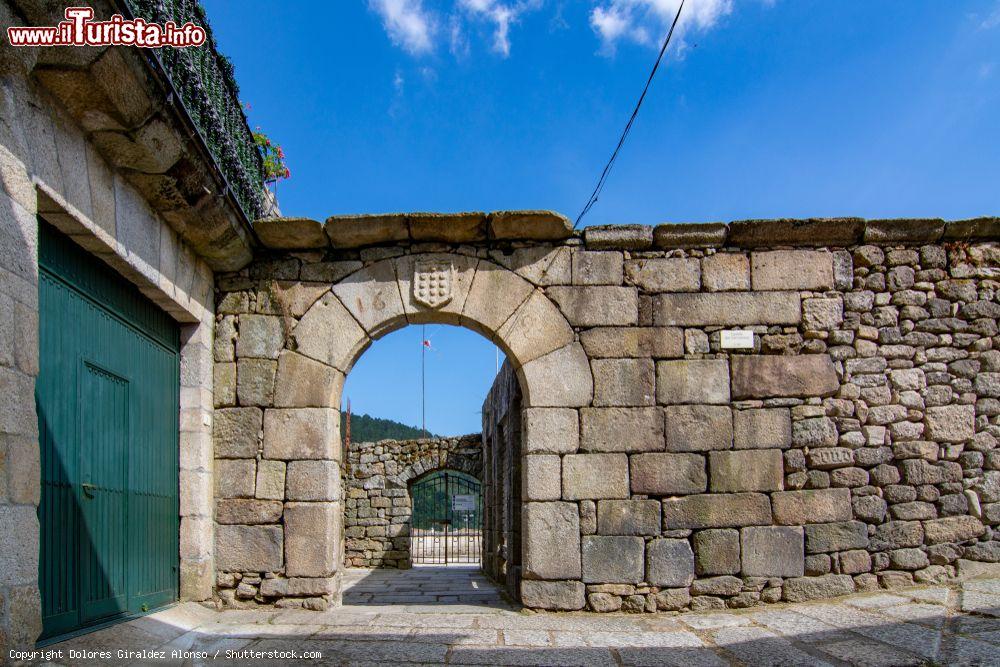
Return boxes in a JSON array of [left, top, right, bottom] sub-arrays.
[[284, 502, 343, 577]]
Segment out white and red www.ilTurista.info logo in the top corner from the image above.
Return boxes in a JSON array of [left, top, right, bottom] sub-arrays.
[[7, 7, 206, 49]]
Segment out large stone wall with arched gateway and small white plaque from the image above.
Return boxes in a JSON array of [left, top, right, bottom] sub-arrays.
[[215, 212, 1000, 610]]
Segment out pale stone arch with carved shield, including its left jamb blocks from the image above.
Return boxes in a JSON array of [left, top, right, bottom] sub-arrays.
[[229, 253, 593, 600]]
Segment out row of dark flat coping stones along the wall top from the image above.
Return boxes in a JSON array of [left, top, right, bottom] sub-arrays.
[[254, 215, 1000, 250]]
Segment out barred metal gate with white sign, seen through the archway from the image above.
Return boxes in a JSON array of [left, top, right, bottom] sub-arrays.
[[410, 470, 483, 565]]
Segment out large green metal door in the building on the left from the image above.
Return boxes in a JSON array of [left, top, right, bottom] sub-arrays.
[[35, 220, 180, 639]]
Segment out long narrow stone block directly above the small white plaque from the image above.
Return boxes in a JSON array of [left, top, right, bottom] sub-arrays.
[[653, 292, 802, 327]]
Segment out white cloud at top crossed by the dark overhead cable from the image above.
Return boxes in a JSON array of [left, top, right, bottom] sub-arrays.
[[590, 0, 733, 53]]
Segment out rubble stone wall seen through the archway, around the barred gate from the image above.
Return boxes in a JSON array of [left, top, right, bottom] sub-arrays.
[[344, 433, 483, 568]]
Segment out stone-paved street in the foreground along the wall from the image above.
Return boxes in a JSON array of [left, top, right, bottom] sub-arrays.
[[21, 574, 1000, 667]]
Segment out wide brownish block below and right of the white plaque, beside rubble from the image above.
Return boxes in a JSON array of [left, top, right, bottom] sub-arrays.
[[732, 354, 840, 400]]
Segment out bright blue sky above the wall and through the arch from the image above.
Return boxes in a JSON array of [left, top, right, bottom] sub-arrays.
[[204, 0, 1000, 433]]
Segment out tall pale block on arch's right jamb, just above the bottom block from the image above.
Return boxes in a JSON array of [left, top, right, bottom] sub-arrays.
[[521, 502, 584, 579]]
